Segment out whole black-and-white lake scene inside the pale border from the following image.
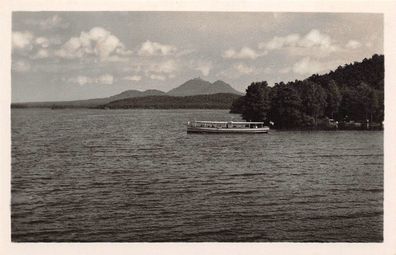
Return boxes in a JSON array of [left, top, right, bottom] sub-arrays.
[[10, 11, 384, 243]]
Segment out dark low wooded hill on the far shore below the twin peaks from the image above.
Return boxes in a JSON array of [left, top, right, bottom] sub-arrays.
[[100, 93, 240, 109]]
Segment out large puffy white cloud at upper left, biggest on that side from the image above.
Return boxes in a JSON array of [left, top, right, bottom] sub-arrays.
[[55, 27, 132, 61]]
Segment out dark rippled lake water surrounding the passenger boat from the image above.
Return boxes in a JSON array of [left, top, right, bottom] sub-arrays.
[[11, 109, 383, 242]]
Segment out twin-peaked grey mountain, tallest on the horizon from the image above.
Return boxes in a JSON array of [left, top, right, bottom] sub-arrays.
[[167, 78, 242, 96]]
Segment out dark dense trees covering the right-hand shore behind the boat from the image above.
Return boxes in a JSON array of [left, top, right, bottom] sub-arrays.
[[230, 54, 384, 129]]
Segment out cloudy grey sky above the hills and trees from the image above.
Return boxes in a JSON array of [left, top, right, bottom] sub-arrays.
[[11, 12, 384, 102]]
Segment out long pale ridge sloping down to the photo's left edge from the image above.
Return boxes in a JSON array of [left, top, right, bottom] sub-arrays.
[[11, 89, 165, 108]]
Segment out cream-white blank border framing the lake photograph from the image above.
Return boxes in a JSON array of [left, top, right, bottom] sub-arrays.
[[0, 0, 396, 255]]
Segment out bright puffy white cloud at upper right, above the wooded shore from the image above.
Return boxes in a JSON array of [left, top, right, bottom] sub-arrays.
[[258, 29, 340, 57]]
